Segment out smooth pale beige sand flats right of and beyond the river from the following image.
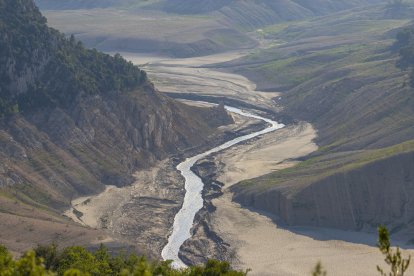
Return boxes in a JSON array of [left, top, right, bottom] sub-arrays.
[[136, 53, 414, 275]]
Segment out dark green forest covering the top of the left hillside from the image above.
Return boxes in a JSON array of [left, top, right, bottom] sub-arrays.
[[0, 0, 146, 116]]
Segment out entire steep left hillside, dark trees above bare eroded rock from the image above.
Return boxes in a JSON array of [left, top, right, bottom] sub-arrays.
[[0, 0, 233, 252]]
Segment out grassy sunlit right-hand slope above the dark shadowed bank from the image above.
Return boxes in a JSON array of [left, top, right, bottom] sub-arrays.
[[231, 4, 414, 211]]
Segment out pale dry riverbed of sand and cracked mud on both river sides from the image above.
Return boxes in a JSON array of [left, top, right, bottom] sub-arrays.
[[64, 53, 414, 275]]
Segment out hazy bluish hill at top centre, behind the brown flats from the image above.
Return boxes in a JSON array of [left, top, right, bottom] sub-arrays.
[[154, 0, 384, 29]]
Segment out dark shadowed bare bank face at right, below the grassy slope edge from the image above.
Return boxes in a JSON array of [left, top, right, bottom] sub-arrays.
[[234, 152, 414, 234]]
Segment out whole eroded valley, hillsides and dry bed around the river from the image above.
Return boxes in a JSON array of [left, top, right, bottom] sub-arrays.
[[0, 0, 414, 275]]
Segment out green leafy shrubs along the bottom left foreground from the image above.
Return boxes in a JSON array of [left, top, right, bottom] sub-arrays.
[[0, 244, 247, 276]]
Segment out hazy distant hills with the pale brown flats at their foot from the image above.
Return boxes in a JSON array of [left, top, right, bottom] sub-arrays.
[[36, 0, 385, 57]]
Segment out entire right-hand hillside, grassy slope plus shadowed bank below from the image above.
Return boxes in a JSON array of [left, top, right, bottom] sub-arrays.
[[227, 3, 414, 235]]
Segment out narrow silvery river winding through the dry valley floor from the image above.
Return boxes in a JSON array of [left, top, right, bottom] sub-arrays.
[[161, 106, 284, 267]]
